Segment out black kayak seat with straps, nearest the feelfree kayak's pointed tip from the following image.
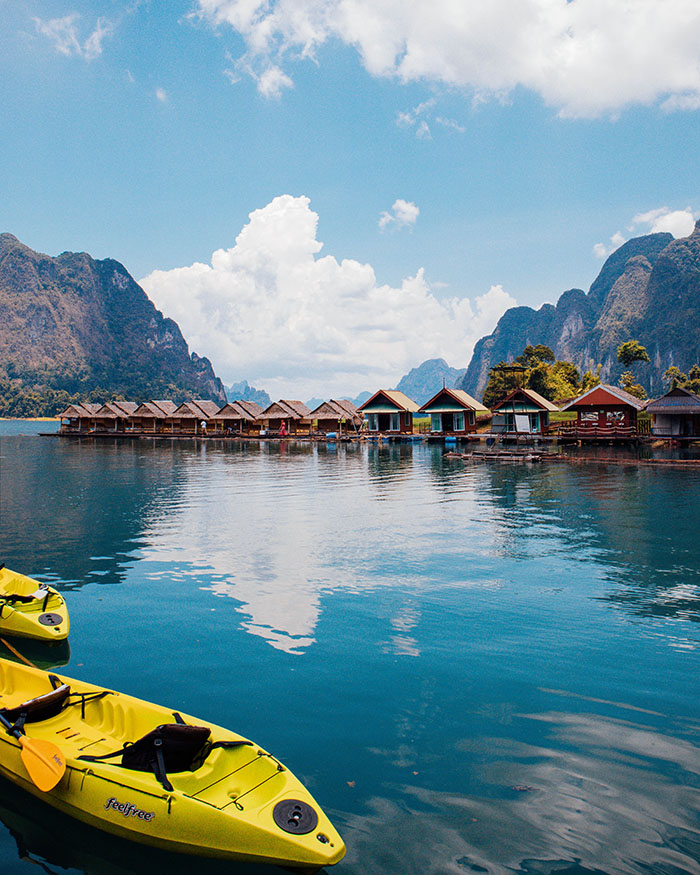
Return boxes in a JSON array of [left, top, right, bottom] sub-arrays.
[[78, 714, 252, 791]]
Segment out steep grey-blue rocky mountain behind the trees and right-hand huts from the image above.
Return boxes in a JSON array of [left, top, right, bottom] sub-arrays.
[[460, 229, 700, 397]]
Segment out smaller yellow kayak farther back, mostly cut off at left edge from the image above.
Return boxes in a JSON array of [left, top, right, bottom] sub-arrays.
[[0, 565, 70, 641]]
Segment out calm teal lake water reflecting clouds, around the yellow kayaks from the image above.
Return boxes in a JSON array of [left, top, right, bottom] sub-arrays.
[[0, 423, 700, 875]]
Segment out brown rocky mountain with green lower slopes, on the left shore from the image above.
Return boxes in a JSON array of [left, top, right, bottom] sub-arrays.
[[0, 234, 226, 404]]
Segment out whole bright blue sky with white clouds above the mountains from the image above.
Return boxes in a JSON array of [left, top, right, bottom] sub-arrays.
[[0, 0, 700, 398]]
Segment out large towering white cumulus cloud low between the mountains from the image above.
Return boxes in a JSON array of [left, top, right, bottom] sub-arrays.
[[141, 195, 516, 400]]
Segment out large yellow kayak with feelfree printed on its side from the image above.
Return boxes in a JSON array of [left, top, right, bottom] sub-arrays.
[[0, 659, 345, 870]]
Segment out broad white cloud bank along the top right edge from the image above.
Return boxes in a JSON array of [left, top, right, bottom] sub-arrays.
[[197, 0, 700, 117]]
